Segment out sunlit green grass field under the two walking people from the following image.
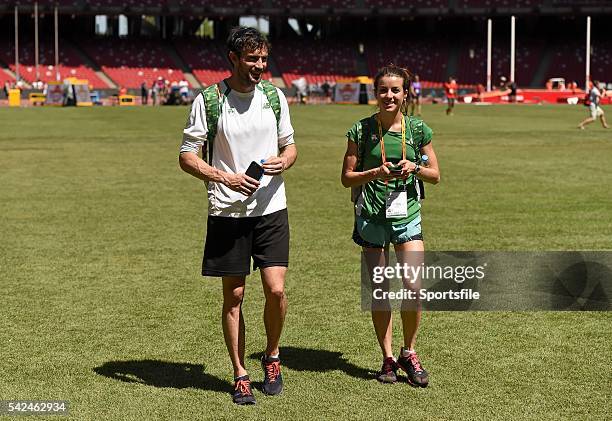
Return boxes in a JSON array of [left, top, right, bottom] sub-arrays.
[[0, 105, 612, 420]]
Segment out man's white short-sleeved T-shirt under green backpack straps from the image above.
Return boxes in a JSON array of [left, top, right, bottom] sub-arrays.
[[180, 81, 294, 218]]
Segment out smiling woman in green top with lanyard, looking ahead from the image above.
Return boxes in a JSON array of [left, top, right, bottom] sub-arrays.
[[341, 65, 440, 387]]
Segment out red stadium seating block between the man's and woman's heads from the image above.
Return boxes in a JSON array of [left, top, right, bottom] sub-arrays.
[[272, 40, 357, 86]]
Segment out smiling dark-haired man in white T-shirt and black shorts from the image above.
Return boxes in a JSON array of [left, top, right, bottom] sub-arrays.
[[179, 27, 297, 404]]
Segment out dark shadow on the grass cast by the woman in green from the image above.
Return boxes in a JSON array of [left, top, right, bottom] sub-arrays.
[[249, 346, 374, 380]]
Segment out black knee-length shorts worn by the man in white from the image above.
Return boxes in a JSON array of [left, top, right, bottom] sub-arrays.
[[202, 209, 289, 276]]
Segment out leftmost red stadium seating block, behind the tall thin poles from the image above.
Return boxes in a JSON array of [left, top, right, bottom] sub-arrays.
[[0, 40, 108, 88]]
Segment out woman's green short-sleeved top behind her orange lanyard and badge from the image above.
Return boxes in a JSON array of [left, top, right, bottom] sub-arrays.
[[346, 111, 433, 225]]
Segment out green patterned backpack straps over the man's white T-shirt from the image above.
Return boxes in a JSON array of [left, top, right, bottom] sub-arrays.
[[200, 80, 280, 164]]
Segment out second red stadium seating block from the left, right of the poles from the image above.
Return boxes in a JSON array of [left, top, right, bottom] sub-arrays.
[[80, 39, 185, 88]]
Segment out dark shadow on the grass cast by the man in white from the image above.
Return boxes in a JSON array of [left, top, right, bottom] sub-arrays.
[[93, 360, 233, 393]]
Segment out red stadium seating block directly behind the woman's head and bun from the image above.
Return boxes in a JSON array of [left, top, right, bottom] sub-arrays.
[[366, 40, 449, 88]]
